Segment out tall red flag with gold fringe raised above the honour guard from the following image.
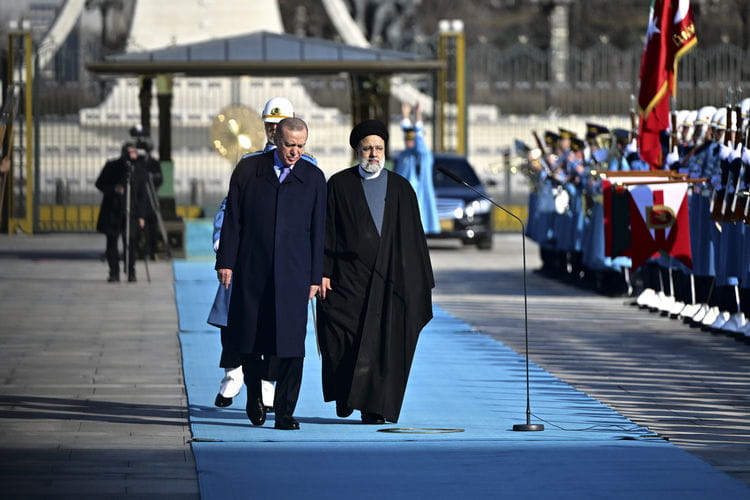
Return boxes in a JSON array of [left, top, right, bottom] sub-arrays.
[[638, 0, 698, 169]]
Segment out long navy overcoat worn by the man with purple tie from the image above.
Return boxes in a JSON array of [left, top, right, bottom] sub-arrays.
[[216, 151, 326, 358]]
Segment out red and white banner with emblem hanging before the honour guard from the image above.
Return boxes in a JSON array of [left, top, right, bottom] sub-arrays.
[[628, 182, 693, 269]]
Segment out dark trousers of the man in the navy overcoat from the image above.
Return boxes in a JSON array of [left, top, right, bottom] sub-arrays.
[[242, 354, 304, 418]]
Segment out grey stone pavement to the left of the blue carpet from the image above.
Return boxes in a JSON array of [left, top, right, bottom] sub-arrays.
[[0, 234, 199, 499]]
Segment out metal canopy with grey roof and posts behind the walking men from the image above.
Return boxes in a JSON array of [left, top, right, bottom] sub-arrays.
[[86, 31, 447, 242]]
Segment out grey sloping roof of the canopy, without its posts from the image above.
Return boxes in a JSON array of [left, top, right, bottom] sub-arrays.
[[86, 31, 445, 76]]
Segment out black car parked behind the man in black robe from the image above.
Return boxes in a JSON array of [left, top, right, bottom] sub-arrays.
[[429, 153, 492, 250]]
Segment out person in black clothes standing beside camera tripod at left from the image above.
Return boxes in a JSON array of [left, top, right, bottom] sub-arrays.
[[96, 142, 148, 282]]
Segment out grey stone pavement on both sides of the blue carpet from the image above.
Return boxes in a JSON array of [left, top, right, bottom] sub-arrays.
[[0, 234, 750, 498]]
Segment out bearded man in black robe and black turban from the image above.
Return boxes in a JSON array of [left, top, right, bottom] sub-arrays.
[[318, 120, 435, 424]]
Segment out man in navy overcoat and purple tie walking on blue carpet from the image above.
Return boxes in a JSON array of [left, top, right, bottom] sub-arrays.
[[216, 118, 326, 430]]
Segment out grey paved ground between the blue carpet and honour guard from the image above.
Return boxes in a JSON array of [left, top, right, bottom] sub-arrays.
[[432, 235, 750, 484]]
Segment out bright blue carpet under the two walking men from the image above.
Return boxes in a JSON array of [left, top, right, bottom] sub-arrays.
[[175, 261, 750, 499]]
